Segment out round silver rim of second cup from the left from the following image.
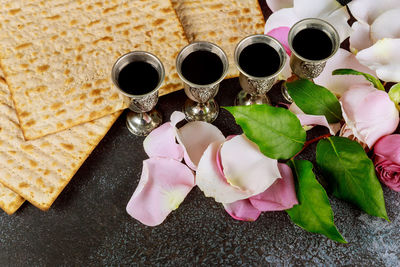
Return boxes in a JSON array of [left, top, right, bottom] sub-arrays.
[[175, 41, 229, 88]]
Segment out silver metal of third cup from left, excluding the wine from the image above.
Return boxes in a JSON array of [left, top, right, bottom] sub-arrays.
[[234, 34, 286, 106]]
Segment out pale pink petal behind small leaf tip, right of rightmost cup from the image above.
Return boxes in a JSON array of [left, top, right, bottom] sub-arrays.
[[314, 48, 375, 97]]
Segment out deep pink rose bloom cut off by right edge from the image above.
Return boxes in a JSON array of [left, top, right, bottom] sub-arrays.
[[374, 134, 400, 192]]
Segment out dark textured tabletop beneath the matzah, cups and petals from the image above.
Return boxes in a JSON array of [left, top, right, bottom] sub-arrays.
[[0, 1, 400, 266]]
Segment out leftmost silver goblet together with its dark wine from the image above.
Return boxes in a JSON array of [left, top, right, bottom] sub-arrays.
[[111, 51, 165, 136]]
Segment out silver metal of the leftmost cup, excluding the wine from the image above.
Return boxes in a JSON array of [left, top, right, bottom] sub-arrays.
[[111, 51, 165, 136]]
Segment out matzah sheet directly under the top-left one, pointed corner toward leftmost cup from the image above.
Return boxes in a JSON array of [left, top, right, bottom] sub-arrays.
[[0, 69, 120, 210]]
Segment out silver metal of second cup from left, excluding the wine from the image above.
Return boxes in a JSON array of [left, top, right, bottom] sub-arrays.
[[176, 42, 229, 123]]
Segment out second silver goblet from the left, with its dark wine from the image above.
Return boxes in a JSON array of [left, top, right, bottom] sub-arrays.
[[176, 42, 229, 122]]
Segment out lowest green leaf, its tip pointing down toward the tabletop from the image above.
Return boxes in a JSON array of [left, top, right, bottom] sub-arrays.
[[286, 160, 347, 243]]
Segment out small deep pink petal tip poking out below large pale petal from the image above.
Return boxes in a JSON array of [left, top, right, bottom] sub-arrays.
[[223, 199, 261, 222]]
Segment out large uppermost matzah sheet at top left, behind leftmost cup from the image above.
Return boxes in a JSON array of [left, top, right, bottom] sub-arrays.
[[0, 0, 187, 140]]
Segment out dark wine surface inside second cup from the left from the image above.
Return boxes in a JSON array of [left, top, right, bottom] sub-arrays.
[[181, 50, 224, 85]]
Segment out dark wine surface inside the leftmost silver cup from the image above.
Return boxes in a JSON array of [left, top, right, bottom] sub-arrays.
[[118, 61, 160, 95]]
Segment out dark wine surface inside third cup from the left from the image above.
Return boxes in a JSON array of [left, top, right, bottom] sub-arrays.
[[239, 43, 281, 77]]
